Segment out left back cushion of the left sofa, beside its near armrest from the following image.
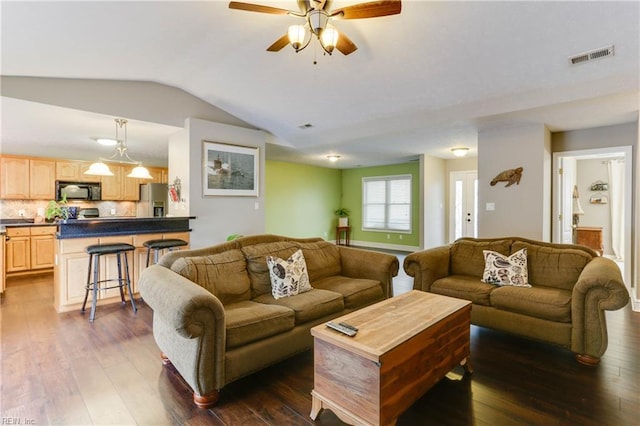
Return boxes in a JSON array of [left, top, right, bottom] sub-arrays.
[[171, 250, 251, 305]]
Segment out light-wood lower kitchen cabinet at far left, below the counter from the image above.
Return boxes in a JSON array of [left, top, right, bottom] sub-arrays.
[[5, 226, 56, 274]]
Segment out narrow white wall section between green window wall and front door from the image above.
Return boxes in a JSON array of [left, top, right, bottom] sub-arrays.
[[421, 155, 447, 248]]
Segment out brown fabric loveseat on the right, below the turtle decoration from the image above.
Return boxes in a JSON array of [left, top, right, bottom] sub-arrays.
[[404, 237, 629, 365]]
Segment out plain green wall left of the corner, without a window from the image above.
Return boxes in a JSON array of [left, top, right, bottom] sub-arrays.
[[265, 160, 342, 240]]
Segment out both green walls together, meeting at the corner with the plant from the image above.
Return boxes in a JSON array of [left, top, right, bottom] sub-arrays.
[[265, 161, 420, 247]]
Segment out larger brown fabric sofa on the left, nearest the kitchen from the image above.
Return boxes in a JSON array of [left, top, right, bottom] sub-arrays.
[[139, 235, 399, 407]]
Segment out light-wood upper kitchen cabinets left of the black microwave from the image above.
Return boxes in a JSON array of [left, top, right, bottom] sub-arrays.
[[0, 156, 56, 200]]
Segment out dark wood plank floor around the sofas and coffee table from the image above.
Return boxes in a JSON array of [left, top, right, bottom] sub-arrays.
[[0, 275, 640, 425]]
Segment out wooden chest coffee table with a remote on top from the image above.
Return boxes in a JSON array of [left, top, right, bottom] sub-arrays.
[[310, 290, 471, 425]]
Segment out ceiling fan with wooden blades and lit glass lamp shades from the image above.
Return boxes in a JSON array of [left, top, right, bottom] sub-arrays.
[[229, 0, 402, 55]]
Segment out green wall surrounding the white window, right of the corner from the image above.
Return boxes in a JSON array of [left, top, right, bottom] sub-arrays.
[[342, 162, 420, 247]]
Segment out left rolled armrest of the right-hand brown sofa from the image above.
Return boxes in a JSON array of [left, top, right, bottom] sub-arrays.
[[403, 246, 451, 291]]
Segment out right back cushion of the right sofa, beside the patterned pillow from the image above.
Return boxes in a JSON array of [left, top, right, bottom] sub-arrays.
[[512, 241, 592, 290]]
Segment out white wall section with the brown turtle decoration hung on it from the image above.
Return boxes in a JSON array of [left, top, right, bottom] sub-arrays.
[[478, 124, 551, 241]]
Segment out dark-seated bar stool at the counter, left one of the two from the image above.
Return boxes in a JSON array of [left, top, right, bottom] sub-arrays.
[[82, 243, 138, 322]]
